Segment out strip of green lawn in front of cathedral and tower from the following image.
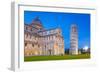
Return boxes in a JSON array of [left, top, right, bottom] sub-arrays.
[[24, 54, 90, 62]]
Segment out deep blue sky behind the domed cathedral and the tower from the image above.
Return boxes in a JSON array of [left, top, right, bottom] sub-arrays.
[[24, 11, 90, 49]]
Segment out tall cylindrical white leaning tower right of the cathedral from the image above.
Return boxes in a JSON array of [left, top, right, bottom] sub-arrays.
[[69, 24, 78, 55]]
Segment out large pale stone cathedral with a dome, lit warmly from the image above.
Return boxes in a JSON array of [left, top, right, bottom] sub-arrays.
[[24, 17, 64, 56]]
